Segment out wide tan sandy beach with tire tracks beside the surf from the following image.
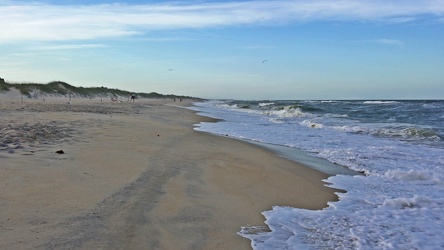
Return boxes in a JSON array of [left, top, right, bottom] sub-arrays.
[[0, 97, 336, 249]]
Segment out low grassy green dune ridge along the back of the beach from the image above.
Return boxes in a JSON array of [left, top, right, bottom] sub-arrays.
[[0, 78, 198, 99]]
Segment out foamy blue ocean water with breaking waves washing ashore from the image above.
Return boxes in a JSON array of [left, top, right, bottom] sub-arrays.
[[188, 100, 444, 249]]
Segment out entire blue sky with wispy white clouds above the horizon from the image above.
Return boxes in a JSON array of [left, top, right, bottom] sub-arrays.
[[0, 0, 444, 100]]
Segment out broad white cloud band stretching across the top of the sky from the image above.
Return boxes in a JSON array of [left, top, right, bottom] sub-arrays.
[[0, 0, 444, 42]]
